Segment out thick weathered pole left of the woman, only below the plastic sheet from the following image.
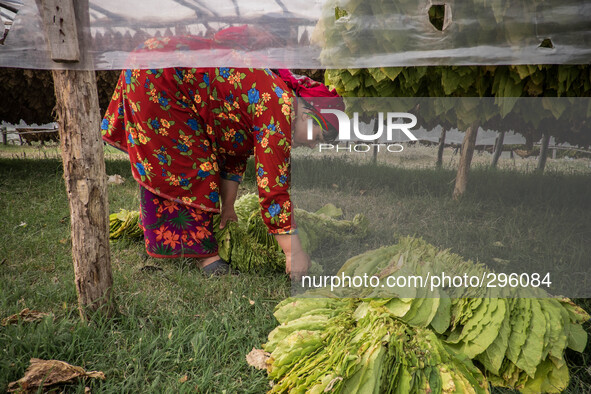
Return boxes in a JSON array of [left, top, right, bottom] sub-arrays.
[[53, 70, 113, 319]]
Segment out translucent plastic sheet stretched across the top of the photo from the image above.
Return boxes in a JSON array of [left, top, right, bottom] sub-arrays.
[[0, 0, 591, 70]]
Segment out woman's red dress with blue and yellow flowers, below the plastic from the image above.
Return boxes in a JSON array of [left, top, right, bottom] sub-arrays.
[[101, 66, 295, 234]]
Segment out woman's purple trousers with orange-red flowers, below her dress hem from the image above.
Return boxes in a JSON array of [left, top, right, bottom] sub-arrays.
[[140, 186, 218, 257]]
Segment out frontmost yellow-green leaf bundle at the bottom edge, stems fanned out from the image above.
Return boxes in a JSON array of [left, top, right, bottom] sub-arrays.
[[264, 298, 488, 393]]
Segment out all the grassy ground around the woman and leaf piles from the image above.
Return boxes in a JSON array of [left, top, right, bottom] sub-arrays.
[[0, 144, 591, 393]]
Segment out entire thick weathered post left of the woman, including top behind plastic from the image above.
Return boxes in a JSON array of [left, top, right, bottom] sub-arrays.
[[39, 0, 115, 320]]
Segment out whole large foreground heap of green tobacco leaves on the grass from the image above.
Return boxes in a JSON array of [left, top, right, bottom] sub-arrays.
[[264, 238, 589, 393]]
